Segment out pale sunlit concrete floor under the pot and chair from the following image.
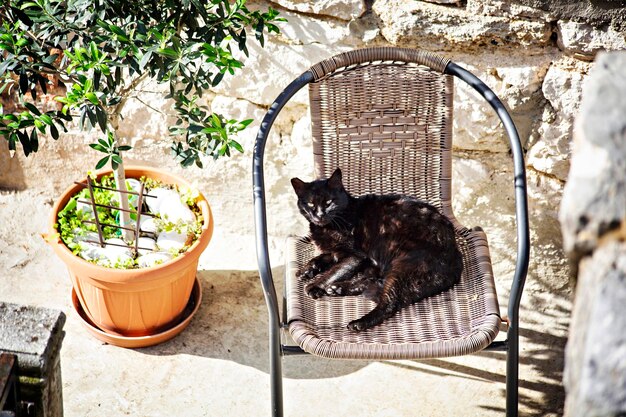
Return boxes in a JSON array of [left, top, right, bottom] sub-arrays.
[[0, 191, 570, 417]]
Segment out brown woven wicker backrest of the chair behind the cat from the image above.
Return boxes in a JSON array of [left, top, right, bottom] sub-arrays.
[[309, 48, 454, 218]]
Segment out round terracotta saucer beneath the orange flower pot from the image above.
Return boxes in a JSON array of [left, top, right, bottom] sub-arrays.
[[72, 277, 202, 348]]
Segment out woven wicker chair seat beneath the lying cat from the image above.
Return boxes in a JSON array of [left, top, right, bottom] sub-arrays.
[[286, 223, 501, 360]]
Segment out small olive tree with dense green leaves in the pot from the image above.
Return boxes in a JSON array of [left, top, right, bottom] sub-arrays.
[[0, 0, 283, 234]]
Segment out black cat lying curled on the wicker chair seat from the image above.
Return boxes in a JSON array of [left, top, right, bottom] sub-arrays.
[[291, 169, 463, 331]]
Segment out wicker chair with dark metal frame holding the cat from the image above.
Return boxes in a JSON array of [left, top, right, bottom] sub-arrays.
[[253, 48, 529, 416]]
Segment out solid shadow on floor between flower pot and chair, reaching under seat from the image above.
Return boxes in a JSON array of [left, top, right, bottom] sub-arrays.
[[138, 269, 369, 379]]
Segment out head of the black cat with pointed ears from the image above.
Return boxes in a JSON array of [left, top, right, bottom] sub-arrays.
[[291, 168, 350, 226]]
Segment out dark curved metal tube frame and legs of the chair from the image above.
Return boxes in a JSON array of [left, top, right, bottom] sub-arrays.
[[253, 48, 530, 417]]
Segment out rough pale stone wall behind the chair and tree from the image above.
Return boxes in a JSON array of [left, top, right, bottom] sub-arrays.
[[0, 0, 626, 272]]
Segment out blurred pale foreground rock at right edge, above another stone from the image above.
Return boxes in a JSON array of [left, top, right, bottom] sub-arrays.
[[560, 52, 626, 260]]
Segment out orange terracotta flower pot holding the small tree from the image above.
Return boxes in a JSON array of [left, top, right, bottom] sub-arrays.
[[47, 166, 213, 337]]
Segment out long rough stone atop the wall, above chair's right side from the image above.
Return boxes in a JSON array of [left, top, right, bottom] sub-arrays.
[[373, 0, 552, 51]]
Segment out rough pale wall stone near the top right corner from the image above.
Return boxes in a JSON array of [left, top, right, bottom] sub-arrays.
[[557, 20, 626, 60]]
